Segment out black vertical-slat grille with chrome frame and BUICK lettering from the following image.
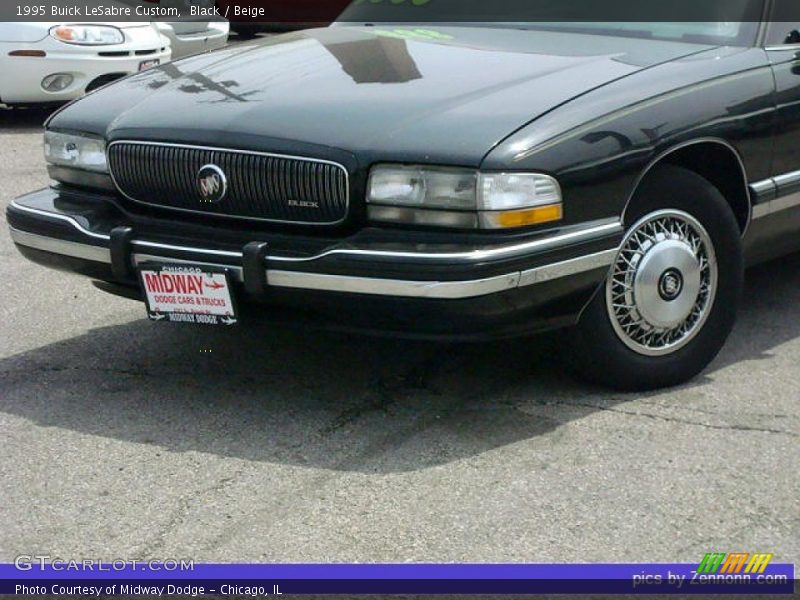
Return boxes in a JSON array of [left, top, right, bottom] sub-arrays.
[[108, 142, 349, 225]]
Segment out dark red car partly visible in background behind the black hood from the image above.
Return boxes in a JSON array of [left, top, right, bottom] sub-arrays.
[[216, 0, 350, 36]]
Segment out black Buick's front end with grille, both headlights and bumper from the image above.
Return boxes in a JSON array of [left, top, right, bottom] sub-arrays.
[[7, 123, 622, 339]]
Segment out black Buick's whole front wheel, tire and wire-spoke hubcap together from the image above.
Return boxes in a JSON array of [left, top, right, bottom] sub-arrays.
[[571, 166, 743, 391]]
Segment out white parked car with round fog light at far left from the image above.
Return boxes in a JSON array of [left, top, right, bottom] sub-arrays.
[[0, 22, 172, 106]]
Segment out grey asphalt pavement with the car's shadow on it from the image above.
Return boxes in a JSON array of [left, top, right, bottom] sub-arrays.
[[0, 99, 800, 562]]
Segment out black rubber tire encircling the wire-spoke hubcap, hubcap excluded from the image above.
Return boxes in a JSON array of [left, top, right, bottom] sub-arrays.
[[567, 166, 744, 391]]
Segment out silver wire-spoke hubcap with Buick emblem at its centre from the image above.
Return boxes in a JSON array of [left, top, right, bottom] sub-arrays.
[[606, 211, 718, 356]]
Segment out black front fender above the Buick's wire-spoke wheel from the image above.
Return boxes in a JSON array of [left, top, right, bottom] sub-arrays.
[[482, 48, 775, 229]]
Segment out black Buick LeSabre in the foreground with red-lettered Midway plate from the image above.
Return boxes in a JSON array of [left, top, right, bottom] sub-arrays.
[[8, 0, 800, 389]]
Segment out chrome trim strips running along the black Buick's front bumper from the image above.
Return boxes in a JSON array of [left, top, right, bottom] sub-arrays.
[[9, 201, 623, 300]]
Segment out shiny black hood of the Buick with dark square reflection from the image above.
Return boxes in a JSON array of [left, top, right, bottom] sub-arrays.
[[52, 26, 708, 166]]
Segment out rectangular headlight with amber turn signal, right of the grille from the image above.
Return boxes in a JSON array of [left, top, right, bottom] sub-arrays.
[[367, 165, 563, 229]]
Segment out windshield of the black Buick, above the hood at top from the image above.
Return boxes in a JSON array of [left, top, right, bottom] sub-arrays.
[[339, 0, 765, 46]]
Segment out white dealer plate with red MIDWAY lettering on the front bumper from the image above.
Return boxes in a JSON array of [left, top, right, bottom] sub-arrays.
[[139, 263, 239, 325]]
